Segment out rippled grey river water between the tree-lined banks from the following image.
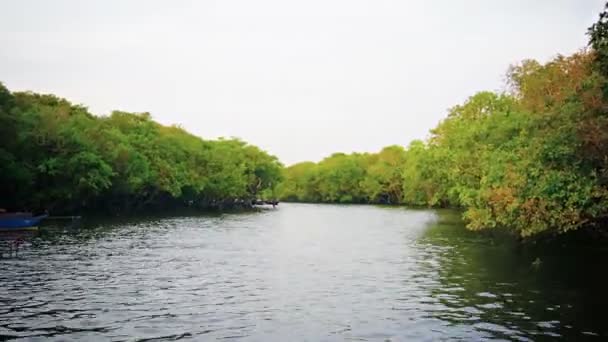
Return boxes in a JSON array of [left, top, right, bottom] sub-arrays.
[[0, 204, 608, 341]]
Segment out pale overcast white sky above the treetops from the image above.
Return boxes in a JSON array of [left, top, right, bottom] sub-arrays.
[[0, 0, 603, 165]]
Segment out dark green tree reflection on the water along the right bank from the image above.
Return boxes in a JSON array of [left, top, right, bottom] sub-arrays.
[[419, 212, 608, 340]]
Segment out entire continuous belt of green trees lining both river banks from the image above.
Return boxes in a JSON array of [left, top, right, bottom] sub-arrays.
[[0, 6, 608, 237]]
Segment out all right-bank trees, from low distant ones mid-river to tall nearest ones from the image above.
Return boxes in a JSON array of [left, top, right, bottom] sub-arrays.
[[279, 7, 608, 236]]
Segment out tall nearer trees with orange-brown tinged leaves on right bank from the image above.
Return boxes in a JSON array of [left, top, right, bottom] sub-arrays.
[[403, 51, 608, 236]]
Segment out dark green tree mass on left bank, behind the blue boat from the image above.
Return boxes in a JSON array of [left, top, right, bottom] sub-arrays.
[[0, 84, 282, 213]]
